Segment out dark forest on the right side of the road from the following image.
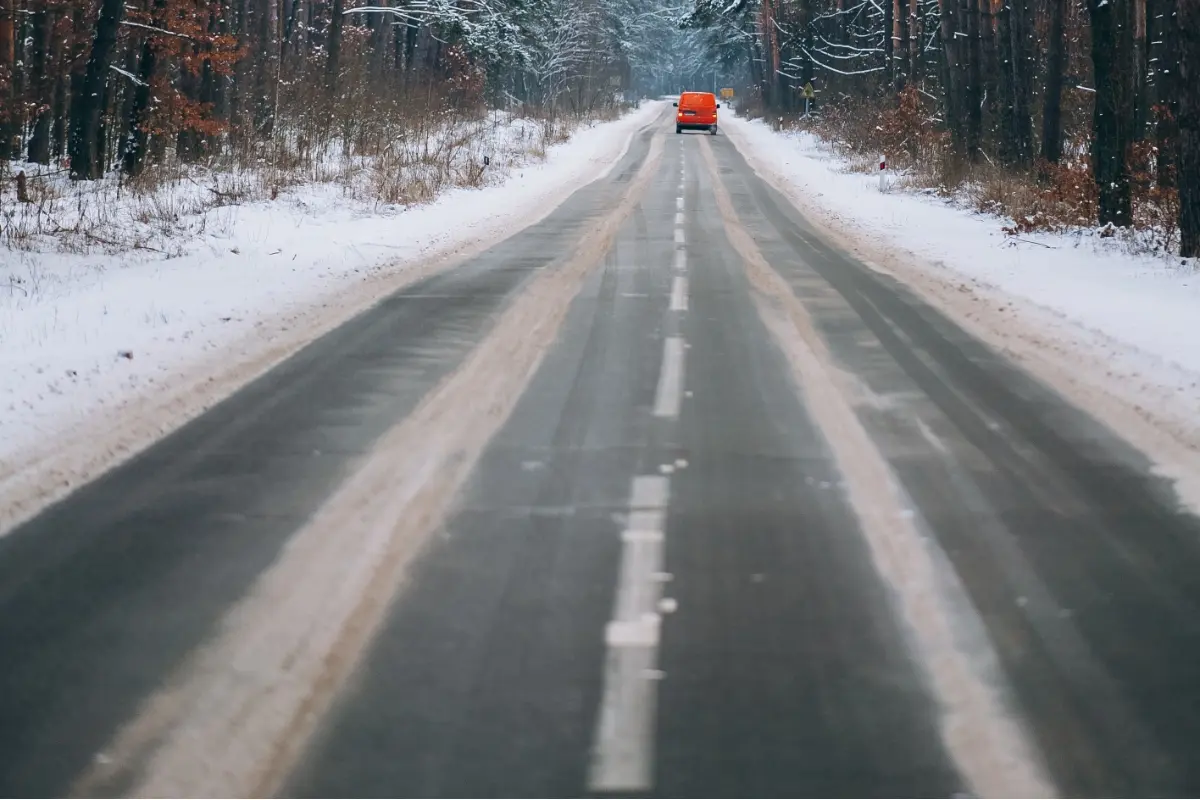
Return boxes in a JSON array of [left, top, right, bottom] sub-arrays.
[[686, 0, 1200, 257]]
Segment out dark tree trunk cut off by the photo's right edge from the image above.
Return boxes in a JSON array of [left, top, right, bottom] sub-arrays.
[[1176, 0, 1200, 258]]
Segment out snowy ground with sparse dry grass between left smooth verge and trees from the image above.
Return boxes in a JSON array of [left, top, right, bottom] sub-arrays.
[[7, 110, 619, 258]]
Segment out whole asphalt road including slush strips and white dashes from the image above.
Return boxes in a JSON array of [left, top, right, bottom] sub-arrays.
[[0, 113, 1200, 798]]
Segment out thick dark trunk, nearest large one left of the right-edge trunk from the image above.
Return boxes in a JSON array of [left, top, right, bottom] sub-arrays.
[[1088, 0, 1132, 227]]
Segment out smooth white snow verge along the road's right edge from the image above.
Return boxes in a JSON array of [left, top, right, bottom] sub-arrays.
[[722, 115, 1200, 510]]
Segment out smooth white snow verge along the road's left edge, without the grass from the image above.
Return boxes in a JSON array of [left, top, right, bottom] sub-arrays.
[[0, 102, 662, 531]]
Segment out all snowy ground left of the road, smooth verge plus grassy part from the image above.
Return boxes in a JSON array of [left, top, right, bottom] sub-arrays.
[[0, 102, 662, 527]]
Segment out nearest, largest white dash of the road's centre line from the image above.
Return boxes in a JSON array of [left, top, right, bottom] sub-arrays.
[[588, 475, 674, 792]]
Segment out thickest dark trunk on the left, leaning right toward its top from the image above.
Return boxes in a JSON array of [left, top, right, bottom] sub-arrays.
[[71, 0, 125, 180]]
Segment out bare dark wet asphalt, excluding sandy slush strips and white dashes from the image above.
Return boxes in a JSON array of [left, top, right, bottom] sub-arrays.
[[0, 115, 1200, 796]]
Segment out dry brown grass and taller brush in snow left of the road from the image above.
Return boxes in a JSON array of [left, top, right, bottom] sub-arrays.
[[0, 82, 620, 257]]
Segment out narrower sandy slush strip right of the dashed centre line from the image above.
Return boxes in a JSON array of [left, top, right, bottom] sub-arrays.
[[700, 134, 1056, 798]]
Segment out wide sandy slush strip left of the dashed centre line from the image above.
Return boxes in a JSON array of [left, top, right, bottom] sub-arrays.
[[73, 134, 662, 796]]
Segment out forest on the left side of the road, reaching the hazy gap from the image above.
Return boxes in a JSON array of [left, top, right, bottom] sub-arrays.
[[0, 0, 713, 179]]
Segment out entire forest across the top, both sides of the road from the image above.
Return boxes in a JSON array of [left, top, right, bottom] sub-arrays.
[[0, 0, 1200, 255]]
